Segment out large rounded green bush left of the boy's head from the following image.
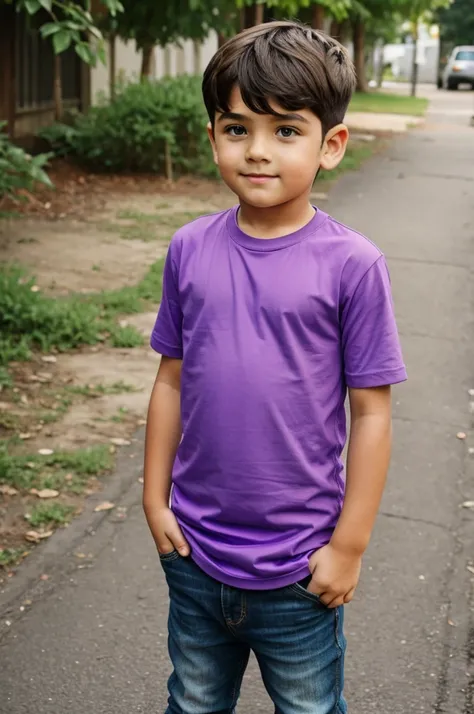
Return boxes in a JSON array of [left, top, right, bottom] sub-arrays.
[[42, 75, 216, 176]]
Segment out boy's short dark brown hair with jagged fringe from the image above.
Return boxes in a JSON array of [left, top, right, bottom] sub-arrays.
[[202, 22, 356, 134]]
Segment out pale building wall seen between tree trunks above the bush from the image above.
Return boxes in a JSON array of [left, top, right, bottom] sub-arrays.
[[90, 33, 218, 104]]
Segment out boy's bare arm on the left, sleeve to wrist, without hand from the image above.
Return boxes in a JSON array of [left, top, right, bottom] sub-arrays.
[[143, 361, 181, 513]]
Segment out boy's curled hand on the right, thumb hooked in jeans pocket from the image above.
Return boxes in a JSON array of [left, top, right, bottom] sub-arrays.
[[308, 543, 362, 608]]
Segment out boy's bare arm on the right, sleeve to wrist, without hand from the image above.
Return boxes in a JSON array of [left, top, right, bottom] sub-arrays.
[[331, 398, 392, 555]]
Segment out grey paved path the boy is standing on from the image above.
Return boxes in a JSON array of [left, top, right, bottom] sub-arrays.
[[0, 93, 474, 714]]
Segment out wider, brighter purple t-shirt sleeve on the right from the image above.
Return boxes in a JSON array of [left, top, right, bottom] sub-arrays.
[[341, 256, 407, 389]]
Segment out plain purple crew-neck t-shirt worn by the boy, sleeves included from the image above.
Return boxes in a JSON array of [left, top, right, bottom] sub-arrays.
[[151, 203, 406, 590]]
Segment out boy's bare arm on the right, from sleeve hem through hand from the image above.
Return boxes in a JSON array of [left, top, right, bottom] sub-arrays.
[[310, 386, 392, 607]]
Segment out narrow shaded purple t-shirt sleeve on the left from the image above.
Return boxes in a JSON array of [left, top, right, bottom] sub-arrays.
[[150, 243, 183, 359]]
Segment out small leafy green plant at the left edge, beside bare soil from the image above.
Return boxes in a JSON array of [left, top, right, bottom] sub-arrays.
[[0, 122, 53, 199]]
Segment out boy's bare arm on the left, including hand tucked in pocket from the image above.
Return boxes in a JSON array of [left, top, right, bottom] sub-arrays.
[[143, 357, 189, 556]]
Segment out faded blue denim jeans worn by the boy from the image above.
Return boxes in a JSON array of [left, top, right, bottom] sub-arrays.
[[160, 551, 347, 714]]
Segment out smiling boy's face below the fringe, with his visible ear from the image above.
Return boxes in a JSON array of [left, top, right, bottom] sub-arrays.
[[208, 87, 348, 208]]
